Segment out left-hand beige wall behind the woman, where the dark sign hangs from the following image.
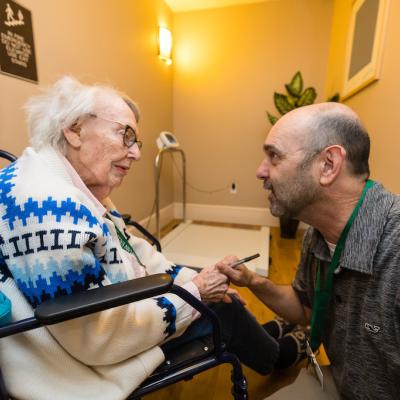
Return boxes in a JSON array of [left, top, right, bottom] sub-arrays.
[[0, 0, 173, 219]]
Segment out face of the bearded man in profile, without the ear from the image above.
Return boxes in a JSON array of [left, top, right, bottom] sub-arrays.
[[257, 123, 319, 218]]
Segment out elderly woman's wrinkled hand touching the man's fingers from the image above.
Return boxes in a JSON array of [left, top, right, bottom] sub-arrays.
[[193, 265, 229, 303]]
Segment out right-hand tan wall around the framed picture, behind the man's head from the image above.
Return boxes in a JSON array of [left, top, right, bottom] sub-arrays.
[[326, 0, 400, 193]]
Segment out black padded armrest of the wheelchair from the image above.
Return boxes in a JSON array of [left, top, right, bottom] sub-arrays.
[[35, 274, 173, 325]]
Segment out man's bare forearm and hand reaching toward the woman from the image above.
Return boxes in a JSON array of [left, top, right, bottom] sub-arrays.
[[217, 257, 311, 325]]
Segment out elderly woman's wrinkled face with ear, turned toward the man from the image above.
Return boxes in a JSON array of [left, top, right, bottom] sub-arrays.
[[65, 94, 141, 200]]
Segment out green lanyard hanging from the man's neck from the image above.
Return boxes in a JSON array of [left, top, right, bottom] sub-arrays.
[[310, 179, 374, 351]]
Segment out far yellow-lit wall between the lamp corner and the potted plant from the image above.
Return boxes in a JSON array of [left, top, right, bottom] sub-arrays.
[[173, 0, 332, 207]]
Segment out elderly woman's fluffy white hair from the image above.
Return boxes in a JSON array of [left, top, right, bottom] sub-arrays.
[[24, 76, 140, 154]]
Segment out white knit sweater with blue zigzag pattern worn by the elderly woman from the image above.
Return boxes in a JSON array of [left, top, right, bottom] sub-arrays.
[[0, 148, 198, 400]]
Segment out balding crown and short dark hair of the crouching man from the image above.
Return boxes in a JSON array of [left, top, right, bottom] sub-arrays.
[[276, 103, 370, 176]]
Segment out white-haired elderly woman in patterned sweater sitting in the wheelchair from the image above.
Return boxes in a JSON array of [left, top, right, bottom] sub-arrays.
[[0, 77, 278, 400]]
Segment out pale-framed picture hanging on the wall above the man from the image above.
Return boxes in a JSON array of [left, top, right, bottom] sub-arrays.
[[342, 0, 390, 99]]
